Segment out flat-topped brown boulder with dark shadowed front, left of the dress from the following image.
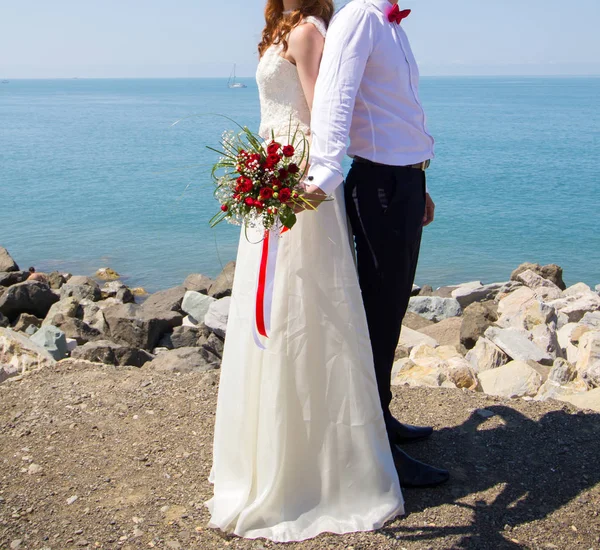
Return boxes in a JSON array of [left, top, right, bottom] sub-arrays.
[[103, 304, 183, 350]]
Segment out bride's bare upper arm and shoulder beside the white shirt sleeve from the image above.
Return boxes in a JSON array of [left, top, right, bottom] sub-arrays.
[[286, 23, 325, 110]]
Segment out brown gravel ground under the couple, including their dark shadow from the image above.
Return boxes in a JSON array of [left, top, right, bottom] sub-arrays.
[[0, 360, 600, 550]]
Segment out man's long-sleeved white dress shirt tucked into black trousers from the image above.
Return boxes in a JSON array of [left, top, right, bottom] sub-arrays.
[[309, 0, 434, 194]]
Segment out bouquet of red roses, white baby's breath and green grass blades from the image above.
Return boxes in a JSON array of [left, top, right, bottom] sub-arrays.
[[208, 126, 308, 231]]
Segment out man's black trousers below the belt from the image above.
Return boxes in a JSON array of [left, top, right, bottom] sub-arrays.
[[345, 161, 425, 436]]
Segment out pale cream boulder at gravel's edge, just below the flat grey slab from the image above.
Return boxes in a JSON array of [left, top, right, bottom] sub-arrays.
[[478, 361, 542, 398]]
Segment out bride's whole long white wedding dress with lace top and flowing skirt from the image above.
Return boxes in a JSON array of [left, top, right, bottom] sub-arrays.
[[207, 18, 404, 542]]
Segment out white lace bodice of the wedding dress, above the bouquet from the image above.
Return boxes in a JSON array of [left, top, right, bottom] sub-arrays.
[[256, 17, 326, 139]]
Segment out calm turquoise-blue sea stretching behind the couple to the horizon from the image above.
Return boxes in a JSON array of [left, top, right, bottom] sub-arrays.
[[0, 77, 600, 291]]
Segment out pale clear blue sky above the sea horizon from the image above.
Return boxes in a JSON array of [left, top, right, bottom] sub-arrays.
[[0, 0, 600, 78]]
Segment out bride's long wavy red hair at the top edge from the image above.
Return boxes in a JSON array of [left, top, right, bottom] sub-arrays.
[[258, 0, 335, 57]]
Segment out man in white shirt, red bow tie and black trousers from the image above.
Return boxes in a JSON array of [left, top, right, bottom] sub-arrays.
[[306, 0, 449, 487]]
